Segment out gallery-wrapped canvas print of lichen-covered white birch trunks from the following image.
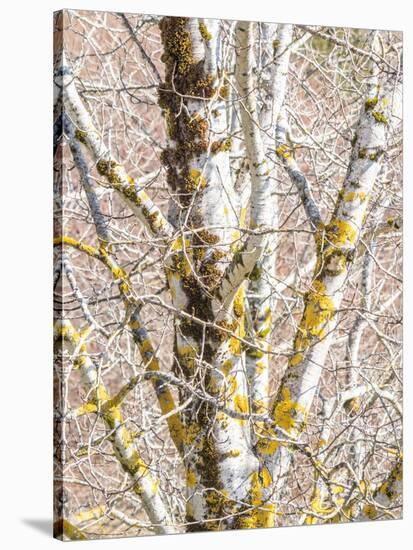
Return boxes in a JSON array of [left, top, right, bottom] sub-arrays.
[[53, 10, 403, 540]]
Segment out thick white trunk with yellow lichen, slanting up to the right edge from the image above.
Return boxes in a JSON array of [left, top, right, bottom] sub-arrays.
[[270, 66, 400, 500]]
